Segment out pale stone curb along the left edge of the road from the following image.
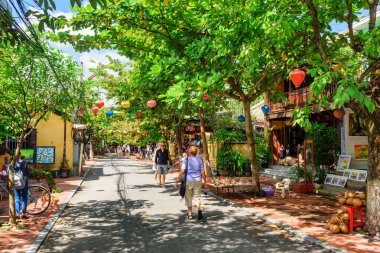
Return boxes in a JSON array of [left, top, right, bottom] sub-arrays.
[[25, 161, 96, 253]]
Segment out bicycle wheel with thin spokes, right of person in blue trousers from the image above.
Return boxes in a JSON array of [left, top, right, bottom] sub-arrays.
[[26, 185, 50, 215]]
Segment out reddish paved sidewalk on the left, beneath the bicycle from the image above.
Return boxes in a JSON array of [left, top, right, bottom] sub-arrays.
[[0, 160, 95, 253]]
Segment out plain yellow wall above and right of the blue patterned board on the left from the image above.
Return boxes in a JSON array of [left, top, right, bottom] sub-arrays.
[[37, 113, 74, 168]]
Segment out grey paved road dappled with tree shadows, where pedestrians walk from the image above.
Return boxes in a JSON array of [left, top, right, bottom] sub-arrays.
[[39, 158, 328, 253]]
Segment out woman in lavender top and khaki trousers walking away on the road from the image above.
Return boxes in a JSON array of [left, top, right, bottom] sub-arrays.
[[175, 146, 206, 220]]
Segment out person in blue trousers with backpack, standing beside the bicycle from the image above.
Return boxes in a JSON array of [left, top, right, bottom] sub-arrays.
[[14, 156, 30, 219]]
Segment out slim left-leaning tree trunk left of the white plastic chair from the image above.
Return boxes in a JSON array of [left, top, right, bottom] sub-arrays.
[[243, 99, 260, 193]]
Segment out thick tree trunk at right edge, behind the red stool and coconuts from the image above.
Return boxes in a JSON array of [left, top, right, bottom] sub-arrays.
[[366, 113, 380, 235]]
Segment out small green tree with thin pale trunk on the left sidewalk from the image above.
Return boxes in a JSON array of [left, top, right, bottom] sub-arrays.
[[0, 43, 79, 224]]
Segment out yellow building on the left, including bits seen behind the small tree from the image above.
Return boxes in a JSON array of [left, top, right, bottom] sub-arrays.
[[0, 113, 74, 169]]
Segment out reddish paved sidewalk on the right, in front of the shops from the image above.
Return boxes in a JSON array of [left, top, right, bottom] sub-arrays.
[[208, 178, 380, 253]]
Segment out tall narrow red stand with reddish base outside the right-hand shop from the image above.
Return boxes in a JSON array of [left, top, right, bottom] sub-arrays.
[[292, 140, 314, 193]]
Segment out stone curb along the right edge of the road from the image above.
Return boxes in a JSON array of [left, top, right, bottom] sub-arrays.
[[202, 189, 348, 253]]
